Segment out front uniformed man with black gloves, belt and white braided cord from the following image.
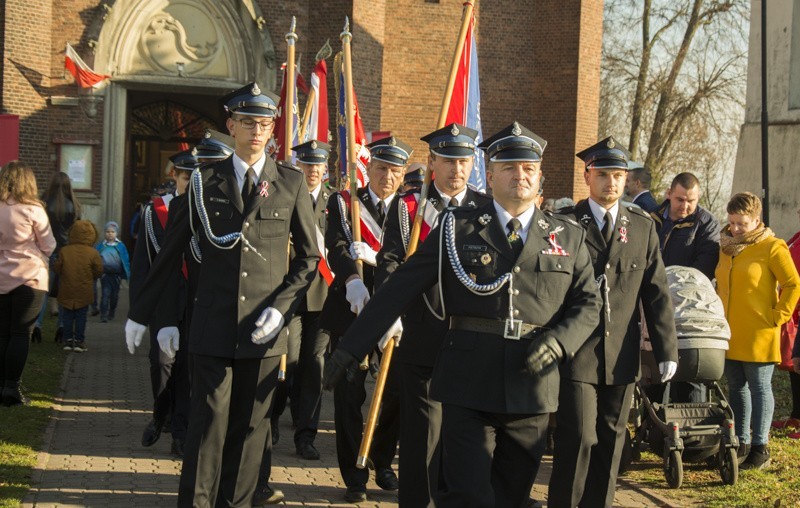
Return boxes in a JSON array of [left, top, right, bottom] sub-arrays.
[[323, 122, 600, 508]]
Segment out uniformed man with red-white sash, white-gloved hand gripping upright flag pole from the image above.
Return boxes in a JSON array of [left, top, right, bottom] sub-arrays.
[[320, 136, 412, 503]]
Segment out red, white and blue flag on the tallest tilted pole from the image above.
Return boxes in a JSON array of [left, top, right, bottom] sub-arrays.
[[445, 16, 486, 191]]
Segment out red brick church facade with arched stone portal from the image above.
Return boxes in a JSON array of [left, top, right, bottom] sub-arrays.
[[0, 0, 603, 223]]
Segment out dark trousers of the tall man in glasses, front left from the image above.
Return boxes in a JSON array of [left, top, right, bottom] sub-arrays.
[[178, 354, 280, 508]]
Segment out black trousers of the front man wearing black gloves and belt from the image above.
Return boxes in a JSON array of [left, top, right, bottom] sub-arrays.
[[437, 404, 548, 508]]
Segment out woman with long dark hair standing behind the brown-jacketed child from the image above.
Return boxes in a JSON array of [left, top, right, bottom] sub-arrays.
[[31, 171, 81, 342]]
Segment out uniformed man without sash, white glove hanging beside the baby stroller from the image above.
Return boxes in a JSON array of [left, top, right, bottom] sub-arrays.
[[547, 138, 678, 507]]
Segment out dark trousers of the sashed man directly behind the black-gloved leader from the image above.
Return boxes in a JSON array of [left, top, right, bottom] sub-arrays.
[[396, 362, 442, 508]]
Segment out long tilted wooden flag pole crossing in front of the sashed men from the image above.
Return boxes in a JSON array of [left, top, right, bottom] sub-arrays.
[[356, 1, 473, 469]]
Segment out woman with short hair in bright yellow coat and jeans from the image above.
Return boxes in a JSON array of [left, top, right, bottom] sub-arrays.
[[716, 192, 800, 469]]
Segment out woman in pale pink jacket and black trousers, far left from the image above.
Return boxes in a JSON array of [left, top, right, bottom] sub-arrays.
[[0, 162, 56, 406]]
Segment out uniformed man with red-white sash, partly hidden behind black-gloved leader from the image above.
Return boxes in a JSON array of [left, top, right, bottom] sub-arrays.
[[375, 123, 492, 507]]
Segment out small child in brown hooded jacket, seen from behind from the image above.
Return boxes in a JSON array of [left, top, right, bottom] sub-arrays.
[[55, 220, 103, 353]]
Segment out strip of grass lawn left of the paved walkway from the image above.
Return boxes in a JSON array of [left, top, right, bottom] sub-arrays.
[[0, 318, 66, 508]]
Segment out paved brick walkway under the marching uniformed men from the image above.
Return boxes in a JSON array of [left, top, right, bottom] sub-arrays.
[[23, 288, 663, 507]]
